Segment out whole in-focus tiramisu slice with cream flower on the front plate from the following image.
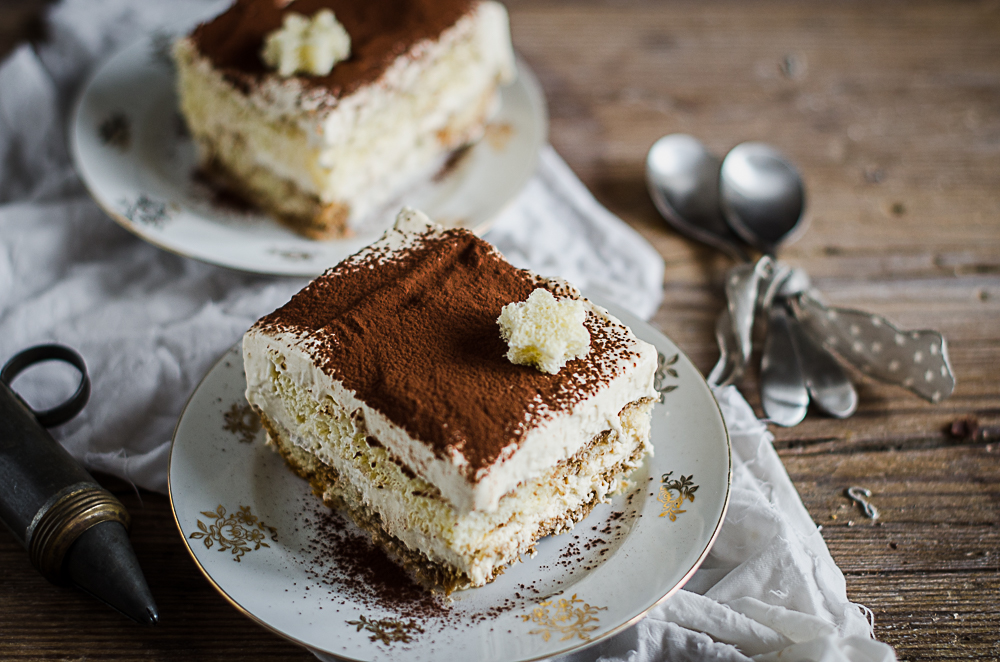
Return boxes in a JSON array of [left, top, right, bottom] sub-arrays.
[[243, 210, 656, 591]]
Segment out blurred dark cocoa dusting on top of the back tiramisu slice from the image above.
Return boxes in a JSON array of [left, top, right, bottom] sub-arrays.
[[191, 0, 474, 97]]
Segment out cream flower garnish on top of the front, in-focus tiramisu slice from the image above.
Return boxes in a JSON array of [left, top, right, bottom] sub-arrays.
[[497, 288, 590, 375]]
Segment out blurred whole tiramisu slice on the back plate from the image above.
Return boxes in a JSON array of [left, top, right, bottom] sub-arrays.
[[174, 0, 514, 239]]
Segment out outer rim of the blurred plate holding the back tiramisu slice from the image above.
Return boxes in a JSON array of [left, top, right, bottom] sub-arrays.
[[66, 33, 549, 278]]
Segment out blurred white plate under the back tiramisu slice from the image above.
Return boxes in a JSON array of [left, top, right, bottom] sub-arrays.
[[70, 35, 548, 276]]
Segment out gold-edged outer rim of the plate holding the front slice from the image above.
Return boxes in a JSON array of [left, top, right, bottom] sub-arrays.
[[167, 297, 733, 662]]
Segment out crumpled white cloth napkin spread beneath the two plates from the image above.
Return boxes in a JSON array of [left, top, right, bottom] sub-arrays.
[[0, 0, 894, 662]]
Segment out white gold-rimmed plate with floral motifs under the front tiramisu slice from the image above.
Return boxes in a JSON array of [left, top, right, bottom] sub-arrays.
[[168, 306, 732, 662]]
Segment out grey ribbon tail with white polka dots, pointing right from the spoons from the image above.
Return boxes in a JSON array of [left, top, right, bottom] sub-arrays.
[[792, 292, 955, 403]]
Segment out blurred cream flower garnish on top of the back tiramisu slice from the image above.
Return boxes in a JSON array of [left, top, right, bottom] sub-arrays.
[[260, 9, 351, 76]]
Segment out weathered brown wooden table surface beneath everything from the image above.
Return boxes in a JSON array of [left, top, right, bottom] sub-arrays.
[[0, 0, 1000, 660]]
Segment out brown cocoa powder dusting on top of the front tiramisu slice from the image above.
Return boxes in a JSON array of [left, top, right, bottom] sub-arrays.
[[257, 230, 636, 482]]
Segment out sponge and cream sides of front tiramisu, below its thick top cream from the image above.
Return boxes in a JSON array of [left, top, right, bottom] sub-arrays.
[[247, 358, 652, 586]]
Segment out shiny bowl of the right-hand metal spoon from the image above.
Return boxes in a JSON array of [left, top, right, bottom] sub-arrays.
[[719, 142, 805, 255]]
